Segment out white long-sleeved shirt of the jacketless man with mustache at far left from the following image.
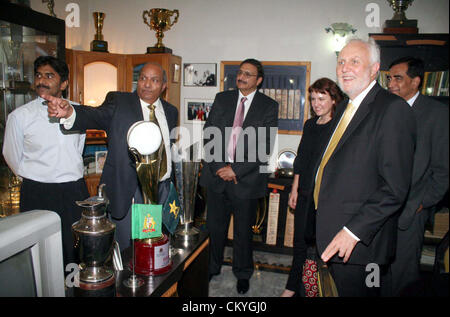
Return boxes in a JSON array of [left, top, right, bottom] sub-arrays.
[[3, 97, 86, 183]]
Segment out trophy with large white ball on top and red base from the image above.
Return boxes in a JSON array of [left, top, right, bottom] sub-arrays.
[[126, 113, 171, 274]]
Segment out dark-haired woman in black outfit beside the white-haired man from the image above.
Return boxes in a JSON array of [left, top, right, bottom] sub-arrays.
[[281, 78, 343, 297]]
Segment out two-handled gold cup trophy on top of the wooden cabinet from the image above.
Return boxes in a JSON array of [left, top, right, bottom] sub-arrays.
[[142, 8, 179, 54]]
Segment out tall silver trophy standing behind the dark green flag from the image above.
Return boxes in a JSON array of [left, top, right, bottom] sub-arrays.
[[174, 143, 200, 243]]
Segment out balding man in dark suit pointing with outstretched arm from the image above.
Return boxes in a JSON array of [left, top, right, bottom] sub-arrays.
[[43, 63, 178, 250]]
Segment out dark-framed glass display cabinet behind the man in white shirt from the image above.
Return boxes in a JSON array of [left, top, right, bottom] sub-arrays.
[[0, 2, 65, 217]]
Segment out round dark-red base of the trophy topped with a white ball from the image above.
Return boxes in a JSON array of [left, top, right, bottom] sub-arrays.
[[130, 234, 172, 275]]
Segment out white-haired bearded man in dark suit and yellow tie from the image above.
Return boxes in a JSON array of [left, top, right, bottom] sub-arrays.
[[314, 40, 416, 296]]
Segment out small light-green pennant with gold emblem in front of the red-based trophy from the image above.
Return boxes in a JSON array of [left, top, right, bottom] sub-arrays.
[[131, 204, 162, 239]]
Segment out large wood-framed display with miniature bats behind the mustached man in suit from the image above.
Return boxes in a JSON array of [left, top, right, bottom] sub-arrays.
[[220, 61, 311, 134]]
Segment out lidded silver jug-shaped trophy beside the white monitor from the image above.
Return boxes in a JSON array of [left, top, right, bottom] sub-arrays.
[[72, 184, 116, 283]]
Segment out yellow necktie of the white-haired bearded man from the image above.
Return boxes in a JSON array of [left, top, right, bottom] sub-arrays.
[[314, 103, 356, 209]]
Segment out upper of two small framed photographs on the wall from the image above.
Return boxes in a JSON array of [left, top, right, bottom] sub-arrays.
[[183, 63, 217, 87]]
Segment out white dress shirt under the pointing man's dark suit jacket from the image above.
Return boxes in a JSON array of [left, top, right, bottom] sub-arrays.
[[60, 98, 172, 181]]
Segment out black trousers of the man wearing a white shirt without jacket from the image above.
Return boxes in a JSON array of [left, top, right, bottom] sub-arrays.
[[20, 178, 89, 267]]
